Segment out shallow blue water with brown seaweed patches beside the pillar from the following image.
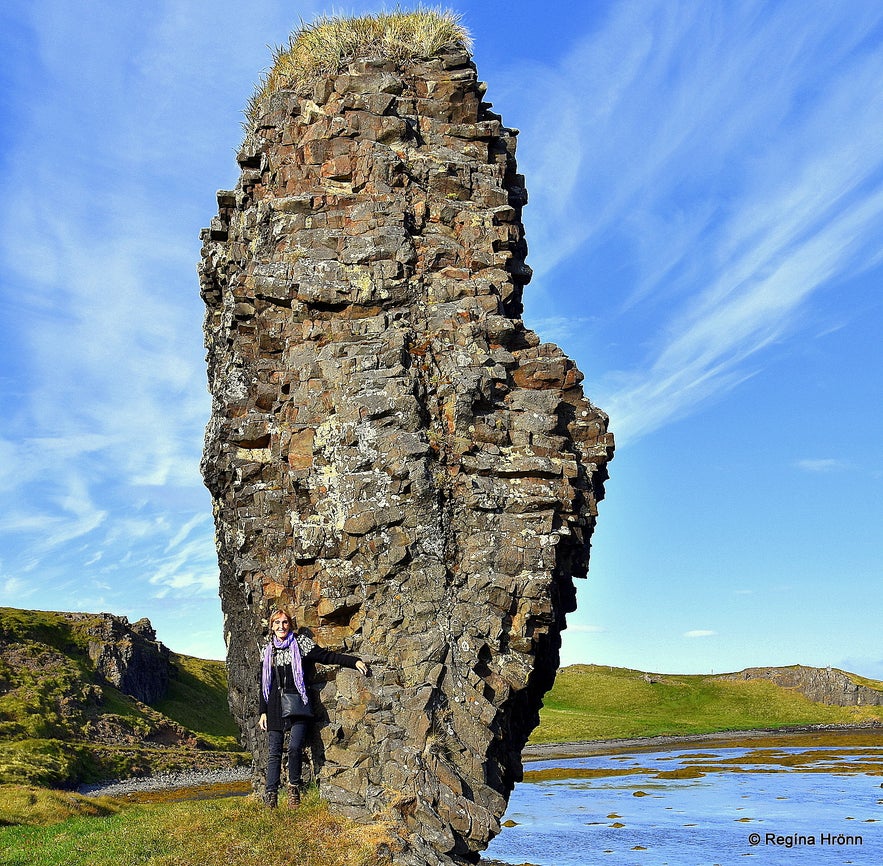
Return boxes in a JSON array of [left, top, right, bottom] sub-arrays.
[[485, 745, 883, 866]]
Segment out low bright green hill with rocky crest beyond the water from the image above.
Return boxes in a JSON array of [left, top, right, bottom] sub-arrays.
[[530, 665, 883, 743]]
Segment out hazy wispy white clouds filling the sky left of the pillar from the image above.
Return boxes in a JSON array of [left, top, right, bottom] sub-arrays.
[[0, 0, 252, 648]]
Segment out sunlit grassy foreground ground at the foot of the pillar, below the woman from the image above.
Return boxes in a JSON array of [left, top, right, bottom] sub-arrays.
[[0, 788, 395, 866]]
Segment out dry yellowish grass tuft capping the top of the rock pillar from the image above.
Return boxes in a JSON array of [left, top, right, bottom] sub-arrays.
[[246, 6, 472, 122]]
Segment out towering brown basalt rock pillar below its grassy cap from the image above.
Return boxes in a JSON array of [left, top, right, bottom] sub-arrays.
[[200, 42, 613, 863]]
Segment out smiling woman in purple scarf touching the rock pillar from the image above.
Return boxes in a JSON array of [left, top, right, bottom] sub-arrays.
[[258, 610, 368, 807]]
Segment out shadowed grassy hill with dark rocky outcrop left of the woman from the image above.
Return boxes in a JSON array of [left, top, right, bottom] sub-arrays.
[[0, 608, 248, 787]]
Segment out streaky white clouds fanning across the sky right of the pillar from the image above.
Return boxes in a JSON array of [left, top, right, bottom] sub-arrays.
[[500, 2, 883, 443]]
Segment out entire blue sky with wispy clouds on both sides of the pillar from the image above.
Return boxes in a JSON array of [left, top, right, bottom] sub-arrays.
[[0, 0, 883, 678]]
